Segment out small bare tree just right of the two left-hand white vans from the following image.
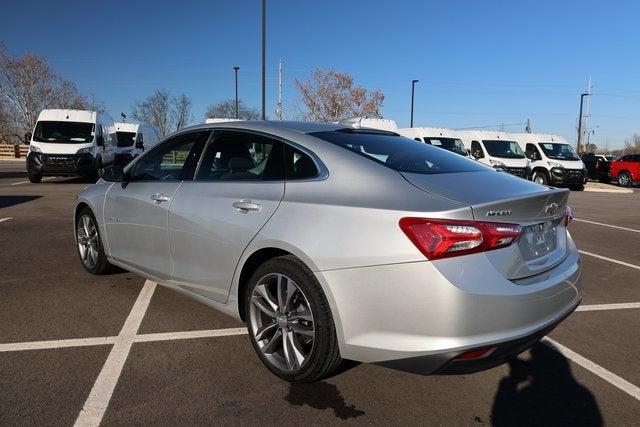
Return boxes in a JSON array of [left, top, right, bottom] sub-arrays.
[[132, 89, 191, 138]]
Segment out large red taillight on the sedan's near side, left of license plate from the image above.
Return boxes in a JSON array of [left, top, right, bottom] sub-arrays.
[[400, 217, 522, 260]]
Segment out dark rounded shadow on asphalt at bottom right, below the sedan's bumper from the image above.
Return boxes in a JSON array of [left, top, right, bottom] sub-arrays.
[[491, 344, 603, 426]]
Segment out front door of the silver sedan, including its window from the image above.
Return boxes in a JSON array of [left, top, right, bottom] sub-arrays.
[[104, 131, 210, 280]]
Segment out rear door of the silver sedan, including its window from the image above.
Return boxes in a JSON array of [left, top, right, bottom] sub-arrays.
[[169, 130, 284, 302]]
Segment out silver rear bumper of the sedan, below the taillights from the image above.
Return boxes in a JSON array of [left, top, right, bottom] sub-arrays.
[[316, 232, 582, 374]]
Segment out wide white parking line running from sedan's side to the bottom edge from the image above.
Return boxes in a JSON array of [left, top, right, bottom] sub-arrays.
[[75, 280, 156, 426]]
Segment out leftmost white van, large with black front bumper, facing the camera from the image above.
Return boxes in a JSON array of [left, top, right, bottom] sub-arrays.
[[24, 110, 115, 183]]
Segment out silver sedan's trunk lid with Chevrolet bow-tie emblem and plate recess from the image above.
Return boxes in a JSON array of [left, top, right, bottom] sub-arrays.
[[402, 170, 569, 280]]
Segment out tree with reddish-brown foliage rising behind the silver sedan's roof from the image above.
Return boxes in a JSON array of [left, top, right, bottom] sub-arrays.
[[294, 69, 384, 122]]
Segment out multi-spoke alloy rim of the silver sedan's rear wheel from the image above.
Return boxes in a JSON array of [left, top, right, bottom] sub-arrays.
[[249, 273, 316, 373]]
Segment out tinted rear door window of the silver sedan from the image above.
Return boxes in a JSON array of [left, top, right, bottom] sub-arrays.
[[198, 130, 284, 181]]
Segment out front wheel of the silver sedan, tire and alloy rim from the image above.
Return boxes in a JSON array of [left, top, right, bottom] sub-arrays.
[[76, 208, 110, 274]]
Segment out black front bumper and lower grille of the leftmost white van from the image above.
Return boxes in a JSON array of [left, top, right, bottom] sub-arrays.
[[27, 152, 95, 175]]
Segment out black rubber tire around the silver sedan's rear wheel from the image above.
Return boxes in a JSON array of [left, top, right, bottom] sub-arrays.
[[244, 255, 355, 383]]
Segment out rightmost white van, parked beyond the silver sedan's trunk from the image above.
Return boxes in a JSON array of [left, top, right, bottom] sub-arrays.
[[513, 133, 587, 190]]
